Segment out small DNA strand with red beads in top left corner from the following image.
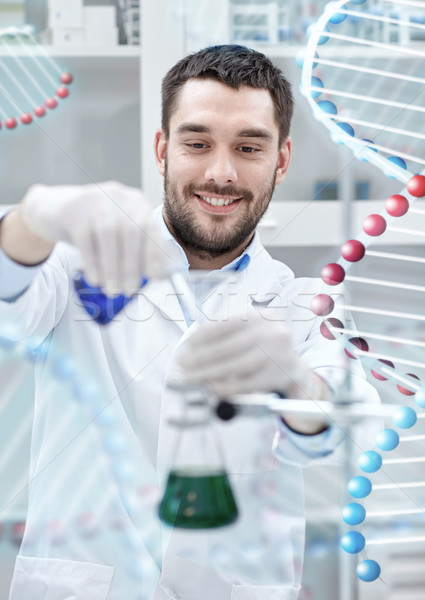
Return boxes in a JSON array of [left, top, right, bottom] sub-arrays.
[[0, 26, 73, 130]]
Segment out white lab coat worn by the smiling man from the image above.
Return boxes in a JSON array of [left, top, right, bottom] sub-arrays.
[[0, 213, 375, 600]]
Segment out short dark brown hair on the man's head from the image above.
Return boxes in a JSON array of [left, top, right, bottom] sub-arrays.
[[162, 44, 294, 145]]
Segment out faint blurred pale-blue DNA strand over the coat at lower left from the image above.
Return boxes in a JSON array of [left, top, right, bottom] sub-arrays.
[[0, 336, 161, 600]]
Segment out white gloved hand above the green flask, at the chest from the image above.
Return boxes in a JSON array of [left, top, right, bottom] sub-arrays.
[[178, 314, 317, 398]]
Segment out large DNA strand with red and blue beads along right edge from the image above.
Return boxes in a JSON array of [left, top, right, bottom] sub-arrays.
[[302, 0, 425, 582]]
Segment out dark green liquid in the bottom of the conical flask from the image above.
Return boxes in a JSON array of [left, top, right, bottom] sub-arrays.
[[159, 469, 238, 529]]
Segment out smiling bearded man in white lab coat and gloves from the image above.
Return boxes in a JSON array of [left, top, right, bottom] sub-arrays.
[[0, 45, 376, 600]]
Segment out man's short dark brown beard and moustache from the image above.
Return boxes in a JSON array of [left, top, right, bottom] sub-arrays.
[[164, 169, 276, 258]]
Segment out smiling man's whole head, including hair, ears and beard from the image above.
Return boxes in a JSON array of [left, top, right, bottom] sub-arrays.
[[155, 48, 293, 268]]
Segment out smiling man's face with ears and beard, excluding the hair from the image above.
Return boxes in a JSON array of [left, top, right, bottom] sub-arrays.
[[156, 79, 290, 257]]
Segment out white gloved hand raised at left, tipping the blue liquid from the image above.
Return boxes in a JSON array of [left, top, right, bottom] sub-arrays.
[[22, 181, 171, 295]]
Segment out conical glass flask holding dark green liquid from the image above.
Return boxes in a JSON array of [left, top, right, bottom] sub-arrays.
[[159, 386, 238, 529]]
